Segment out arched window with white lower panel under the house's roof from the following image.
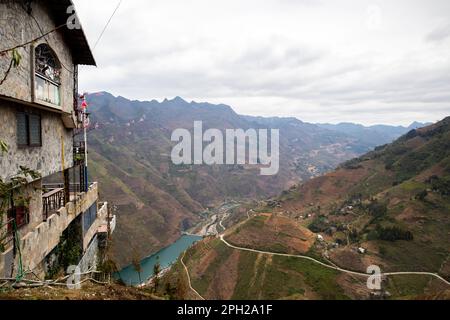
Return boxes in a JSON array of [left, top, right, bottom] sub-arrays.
[[34, 44, 61, 106]]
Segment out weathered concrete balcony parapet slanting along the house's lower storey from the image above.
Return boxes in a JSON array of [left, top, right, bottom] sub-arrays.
[[0, 183, 98, 274]]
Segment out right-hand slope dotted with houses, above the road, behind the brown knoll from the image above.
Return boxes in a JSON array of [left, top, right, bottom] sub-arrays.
[[282, 118, 450, 277]]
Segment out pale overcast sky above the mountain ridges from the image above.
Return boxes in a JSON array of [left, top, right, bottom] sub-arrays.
[[74, 0, 450, 125]]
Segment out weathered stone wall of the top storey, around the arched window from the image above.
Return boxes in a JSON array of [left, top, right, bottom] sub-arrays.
[[0, 1, 74, 113]]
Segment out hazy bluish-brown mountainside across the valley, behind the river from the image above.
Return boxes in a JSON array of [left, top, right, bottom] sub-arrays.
[[83, 93, 380, 266]]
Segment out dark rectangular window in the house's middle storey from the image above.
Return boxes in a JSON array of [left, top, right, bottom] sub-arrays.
[[17, 112, 42, 147]]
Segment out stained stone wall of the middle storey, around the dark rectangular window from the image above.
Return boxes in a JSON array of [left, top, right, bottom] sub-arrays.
[[0, 100, 73, 180]]
